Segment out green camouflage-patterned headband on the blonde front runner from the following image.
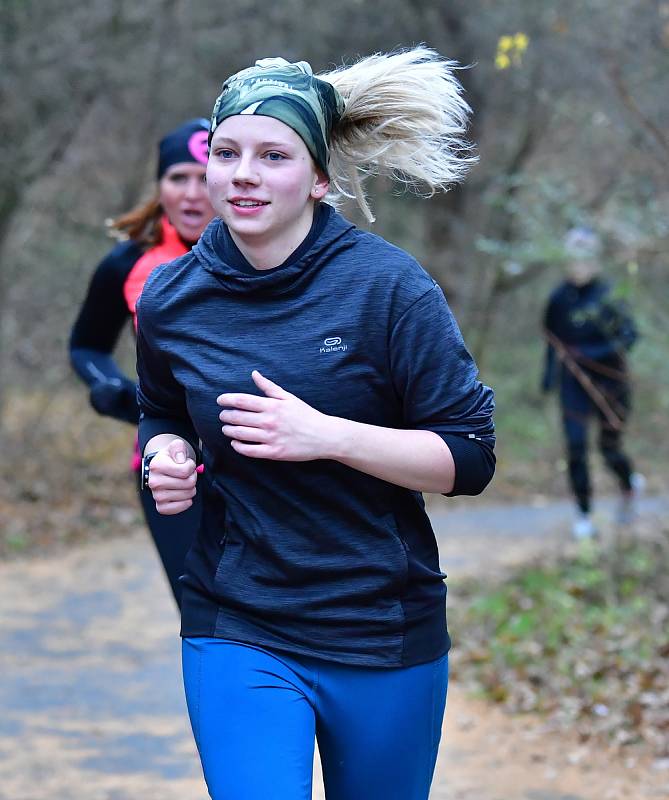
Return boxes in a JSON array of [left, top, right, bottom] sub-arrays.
[[209, 58, 344, 175]]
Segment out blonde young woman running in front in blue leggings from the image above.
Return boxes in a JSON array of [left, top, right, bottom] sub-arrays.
[[138, 53, 494, 800]]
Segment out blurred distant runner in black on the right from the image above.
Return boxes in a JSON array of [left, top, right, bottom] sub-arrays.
[[542, 227, 644, 539]]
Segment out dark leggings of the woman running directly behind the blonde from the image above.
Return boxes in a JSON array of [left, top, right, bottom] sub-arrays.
[[137, 473, 202, 609]]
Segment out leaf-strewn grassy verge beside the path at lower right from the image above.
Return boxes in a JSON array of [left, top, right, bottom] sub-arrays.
[[450, 526, 669, 758]]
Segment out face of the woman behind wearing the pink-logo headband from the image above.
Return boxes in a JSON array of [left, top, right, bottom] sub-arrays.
[[158, 162, 214, 242]]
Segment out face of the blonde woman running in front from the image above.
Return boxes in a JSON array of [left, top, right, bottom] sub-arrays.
[[207, 115, 328, 266]]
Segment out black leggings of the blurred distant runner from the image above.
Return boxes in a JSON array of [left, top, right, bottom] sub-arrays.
[[561, 376, 632, 513]]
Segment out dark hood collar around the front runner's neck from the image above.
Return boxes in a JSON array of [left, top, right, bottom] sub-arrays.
[[192, 204, 355, 294]]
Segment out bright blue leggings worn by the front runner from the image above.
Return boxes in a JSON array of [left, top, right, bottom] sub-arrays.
[[183, 638, 448, 800]]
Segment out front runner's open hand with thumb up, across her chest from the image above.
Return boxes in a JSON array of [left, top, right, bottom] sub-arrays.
[[216, 370, 334, 461]]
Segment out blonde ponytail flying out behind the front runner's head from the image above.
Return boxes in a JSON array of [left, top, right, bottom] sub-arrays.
[[317, 46, 477, 222]]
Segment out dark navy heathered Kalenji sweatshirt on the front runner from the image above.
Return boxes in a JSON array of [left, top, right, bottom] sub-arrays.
[[138, 205, 494, 667]]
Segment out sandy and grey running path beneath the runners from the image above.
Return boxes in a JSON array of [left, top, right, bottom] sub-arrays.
[[0, 500, 669, 800]]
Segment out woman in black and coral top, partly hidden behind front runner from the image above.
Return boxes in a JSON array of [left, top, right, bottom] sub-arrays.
[[70, 119, 214, 604]]
